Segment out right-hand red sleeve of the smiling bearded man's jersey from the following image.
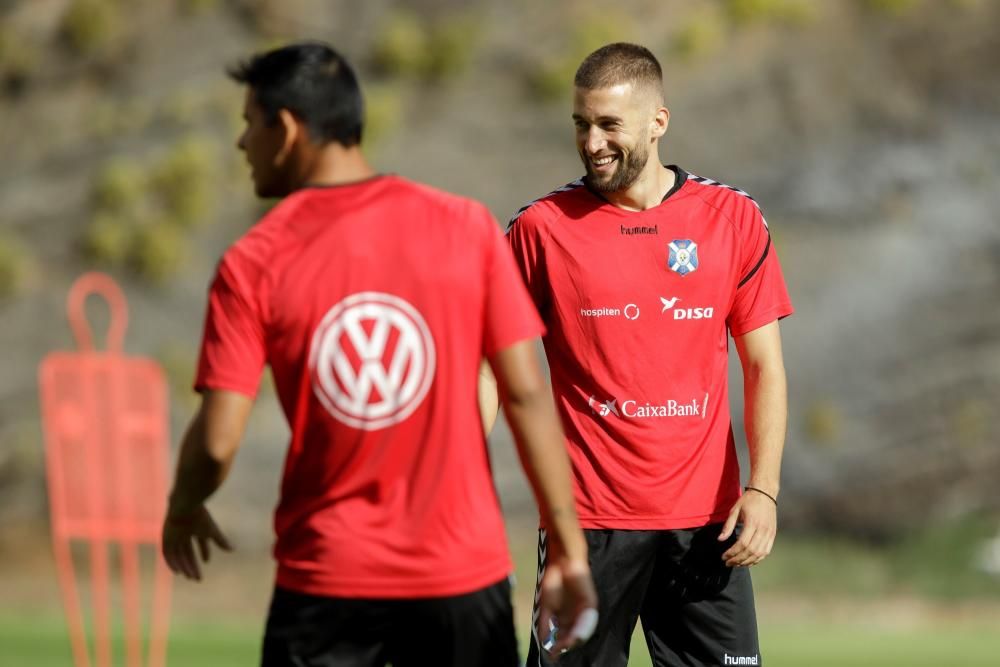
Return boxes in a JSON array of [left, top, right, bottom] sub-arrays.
[[726, 200, 793, 337]]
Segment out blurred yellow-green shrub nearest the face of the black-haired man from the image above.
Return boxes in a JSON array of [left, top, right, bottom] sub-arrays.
[[149, 137, 215, 227]]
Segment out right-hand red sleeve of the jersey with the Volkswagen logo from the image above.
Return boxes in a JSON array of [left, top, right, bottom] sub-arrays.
[[483, 209, 545, 357]]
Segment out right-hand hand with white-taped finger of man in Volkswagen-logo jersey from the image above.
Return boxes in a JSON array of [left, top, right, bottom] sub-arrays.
[[536, 558, 597, 660]]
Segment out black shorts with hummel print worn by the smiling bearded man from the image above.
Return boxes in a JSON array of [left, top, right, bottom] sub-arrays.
[[527, 524, 763, 667]]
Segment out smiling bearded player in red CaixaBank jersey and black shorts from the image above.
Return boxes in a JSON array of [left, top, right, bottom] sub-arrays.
[[488, 43, 792, 667]]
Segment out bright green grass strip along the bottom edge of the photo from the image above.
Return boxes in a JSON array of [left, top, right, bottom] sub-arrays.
[[0, 615, 1000, 667]]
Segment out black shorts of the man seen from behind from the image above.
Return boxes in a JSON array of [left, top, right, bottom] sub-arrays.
[[261, 579, 521, 667]]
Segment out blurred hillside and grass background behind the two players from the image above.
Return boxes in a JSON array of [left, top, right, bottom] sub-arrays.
[[0, 0, 1000, 665]]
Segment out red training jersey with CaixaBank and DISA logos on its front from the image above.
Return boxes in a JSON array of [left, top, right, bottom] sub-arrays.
[[507, 167, 792, 530]]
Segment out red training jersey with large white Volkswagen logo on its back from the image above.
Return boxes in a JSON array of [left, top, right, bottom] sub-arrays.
[[196, 176, 543, 598]]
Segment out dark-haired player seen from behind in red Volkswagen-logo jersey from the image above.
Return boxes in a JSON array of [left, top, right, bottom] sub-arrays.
[[156, 43, 596, 667]]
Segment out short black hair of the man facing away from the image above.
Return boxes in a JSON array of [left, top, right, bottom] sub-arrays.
[[228, 42, 364, 147]]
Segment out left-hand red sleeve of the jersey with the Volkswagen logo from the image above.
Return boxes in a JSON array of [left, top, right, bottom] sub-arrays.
[[194, 256, 267, 398]]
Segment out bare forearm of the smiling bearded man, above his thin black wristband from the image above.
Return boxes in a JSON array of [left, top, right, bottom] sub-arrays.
[[743, 364, 788, 497]]
